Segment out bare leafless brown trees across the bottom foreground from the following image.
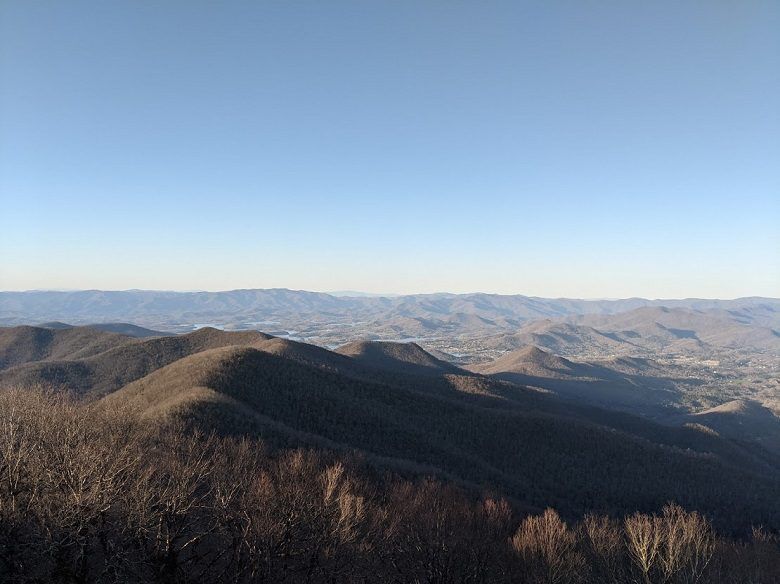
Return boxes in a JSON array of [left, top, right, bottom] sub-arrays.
[[0, 390, 780, 584]]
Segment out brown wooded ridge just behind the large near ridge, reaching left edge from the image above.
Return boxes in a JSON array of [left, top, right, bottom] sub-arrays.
[[0, 326, 471, 397]]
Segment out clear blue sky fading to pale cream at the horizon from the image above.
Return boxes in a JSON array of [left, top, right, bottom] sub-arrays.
[[0, 0, 780, 298]]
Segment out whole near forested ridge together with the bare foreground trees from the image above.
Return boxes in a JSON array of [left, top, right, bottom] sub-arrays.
[[0, 327, 780, 584]]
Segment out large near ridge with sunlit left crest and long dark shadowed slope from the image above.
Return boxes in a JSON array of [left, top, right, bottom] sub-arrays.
[[104, 347, 780, 524]]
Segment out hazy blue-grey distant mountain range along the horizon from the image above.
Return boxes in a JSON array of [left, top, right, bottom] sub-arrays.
[[0, 289, 780, 344]]
